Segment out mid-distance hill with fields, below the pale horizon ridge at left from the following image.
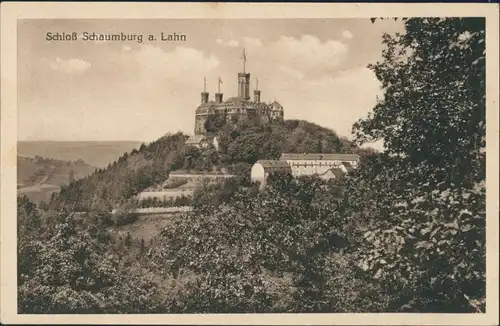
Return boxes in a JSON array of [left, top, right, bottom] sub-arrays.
[[17, 156, 96, 203]]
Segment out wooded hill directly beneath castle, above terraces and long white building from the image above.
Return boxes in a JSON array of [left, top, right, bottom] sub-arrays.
[[47, 120, 376, 211]]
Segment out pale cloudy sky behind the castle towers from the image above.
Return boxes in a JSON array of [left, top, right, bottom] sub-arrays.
[[18, 18, 403, 141]]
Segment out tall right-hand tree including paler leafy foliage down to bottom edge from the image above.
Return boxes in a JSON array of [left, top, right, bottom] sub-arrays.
[[346, 18, 485, 312]]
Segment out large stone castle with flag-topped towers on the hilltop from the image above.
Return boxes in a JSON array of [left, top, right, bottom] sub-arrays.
[[194, 49, 283, 135]]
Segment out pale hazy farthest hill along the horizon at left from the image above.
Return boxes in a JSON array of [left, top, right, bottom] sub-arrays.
[[17, 141, 141, 167]]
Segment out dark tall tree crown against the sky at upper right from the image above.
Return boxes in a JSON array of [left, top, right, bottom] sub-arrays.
[[353, 18, 486, 184]]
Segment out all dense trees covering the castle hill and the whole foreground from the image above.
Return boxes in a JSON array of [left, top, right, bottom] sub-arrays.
[[18, 18, 486, 313]]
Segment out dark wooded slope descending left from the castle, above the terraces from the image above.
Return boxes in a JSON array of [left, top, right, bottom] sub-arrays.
[[49, 133, 187, 211]]
